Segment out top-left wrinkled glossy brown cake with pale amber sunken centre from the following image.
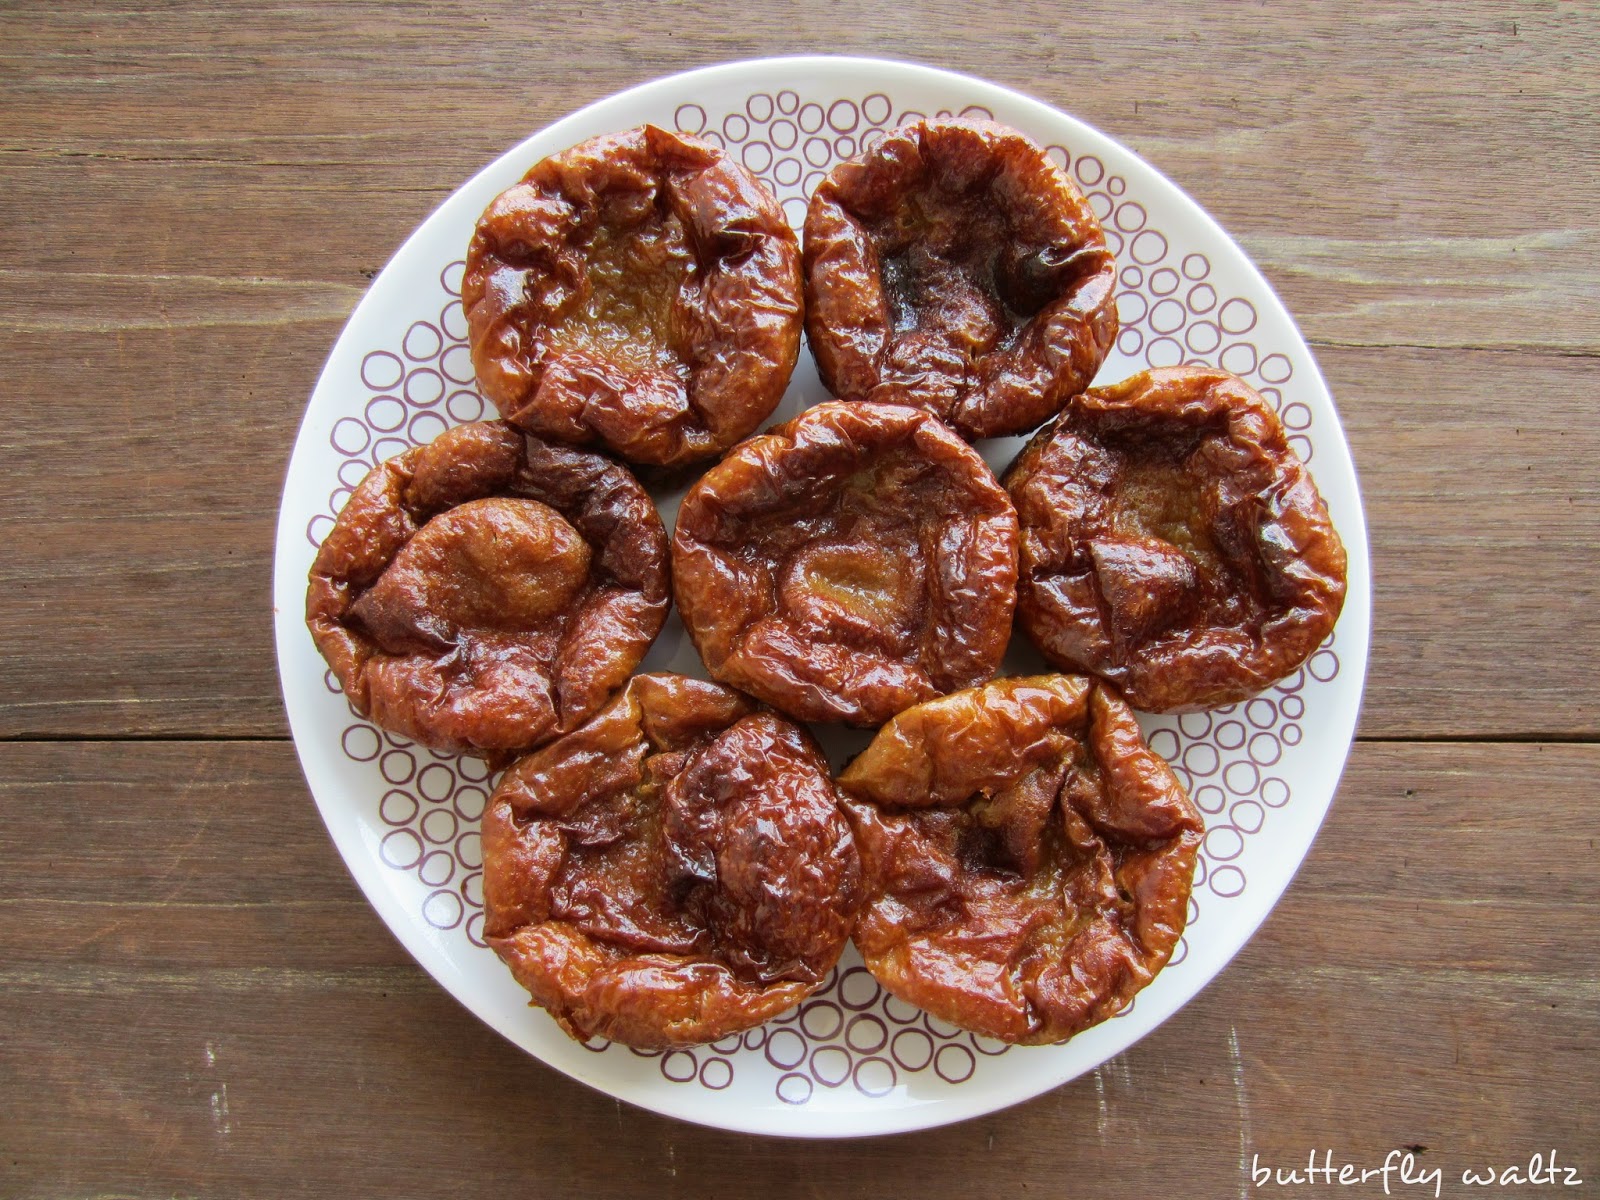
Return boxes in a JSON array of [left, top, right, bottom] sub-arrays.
[[461, 125, 802, 466]]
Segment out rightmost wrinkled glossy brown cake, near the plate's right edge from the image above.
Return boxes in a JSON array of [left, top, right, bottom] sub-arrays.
[[1005, 366, 1346, 712]]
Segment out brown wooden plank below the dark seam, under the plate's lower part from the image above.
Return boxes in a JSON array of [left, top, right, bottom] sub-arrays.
[[0, 742, 1600, 1200]]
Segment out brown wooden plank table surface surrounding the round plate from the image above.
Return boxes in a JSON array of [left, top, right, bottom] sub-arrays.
[[0, 0, 1600, 1198]]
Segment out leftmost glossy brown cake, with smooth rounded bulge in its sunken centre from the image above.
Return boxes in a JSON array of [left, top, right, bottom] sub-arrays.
[[306, 421, 669, 758]]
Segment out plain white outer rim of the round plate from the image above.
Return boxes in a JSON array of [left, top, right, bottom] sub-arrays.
[[272, 54, 1373, 1139]]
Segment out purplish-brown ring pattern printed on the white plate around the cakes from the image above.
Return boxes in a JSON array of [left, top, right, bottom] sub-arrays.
[[306, 82, 1339, 1106]]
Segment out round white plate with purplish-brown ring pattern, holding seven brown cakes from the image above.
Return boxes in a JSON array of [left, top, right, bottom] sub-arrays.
[[274, 58, 1371, 1136]]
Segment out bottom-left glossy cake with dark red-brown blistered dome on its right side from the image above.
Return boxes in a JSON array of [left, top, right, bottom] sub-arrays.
[[483, 675, 861, 1048]]
